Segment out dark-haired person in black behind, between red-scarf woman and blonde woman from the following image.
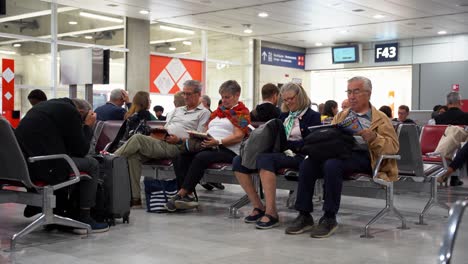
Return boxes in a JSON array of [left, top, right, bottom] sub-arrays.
[[250, 83, 281, 122]]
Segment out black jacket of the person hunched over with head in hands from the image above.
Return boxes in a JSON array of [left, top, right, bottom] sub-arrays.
[[15, 98, 92, 183]]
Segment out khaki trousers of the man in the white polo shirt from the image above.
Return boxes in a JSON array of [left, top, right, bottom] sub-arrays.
[[115, 134, 180, 199]]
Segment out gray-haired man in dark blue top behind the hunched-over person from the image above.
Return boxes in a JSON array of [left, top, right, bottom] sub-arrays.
[[95, 89, 130, 121]]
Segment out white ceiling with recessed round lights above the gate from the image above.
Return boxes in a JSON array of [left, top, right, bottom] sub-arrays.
[[40, 0, 468, 48]]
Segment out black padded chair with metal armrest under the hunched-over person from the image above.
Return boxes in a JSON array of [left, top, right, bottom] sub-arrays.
[[0, 118, 91, 250]]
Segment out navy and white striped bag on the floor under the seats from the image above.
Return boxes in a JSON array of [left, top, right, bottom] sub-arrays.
[[144, 177, 178, 213]]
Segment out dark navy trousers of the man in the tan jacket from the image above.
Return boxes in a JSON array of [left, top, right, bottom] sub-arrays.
[[295, 151, 372, 214]]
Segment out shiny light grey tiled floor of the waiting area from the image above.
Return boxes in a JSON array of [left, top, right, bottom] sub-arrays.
[[0, 185, 468, 264]]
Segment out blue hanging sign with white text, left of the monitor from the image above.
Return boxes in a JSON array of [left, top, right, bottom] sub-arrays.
[[261, 47, 305, 69]]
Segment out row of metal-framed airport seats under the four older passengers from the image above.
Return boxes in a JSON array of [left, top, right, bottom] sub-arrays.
[[91, 121, 454, 237]]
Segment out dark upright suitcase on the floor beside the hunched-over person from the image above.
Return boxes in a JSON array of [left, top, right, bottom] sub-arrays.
[[96, 155, 131, 225]]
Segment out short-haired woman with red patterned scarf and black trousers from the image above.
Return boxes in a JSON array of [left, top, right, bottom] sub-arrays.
[[165, 80, 250, 212]]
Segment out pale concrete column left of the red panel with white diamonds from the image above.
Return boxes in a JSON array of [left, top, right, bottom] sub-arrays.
[[125, 17, 150, 98]]
